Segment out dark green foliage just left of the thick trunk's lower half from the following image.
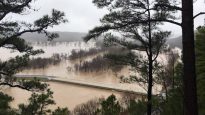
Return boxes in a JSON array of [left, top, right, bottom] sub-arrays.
[[158, 63, 184, 115]]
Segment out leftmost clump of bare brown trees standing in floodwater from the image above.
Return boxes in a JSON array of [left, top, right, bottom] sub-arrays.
[[24, 54, 62, 69]]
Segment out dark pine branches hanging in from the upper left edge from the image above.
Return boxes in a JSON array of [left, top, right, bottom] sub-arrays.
[[0, 0, 67, 90]]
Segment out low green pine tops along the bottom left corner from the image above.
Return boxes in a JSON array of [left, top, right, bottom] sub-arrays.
[[0, 89, 70, 115]]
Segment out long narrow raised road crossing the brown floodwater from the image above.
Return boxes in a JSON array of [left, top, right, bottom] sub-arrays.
[[15, 75, 146, 97]]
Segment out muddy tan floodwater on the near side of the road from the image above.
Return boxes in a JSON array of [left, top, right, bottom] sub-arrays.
[[3, 82, 122, 110]]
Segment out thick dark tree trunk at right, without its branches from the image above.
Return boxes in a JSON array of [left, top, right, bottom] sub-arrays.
[[182, 0, 198, 115]]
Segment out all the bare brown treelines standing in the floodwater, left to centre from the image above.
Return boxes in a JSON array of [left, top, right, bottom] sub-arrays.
[[23, 47, 125, 72]]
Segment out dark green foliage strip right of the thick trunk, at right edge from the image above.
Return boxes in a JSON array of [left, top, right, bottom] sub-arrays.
[[195, 26, 205, 115]]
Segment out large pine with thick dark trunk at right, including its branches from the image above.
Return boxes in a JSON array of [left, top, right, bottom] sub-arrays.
[[87, 0, 205, 115]]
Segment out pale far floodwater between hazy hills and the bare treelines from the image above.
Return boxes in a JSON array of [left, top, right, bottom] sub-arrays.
[[0, 42, 95, 61]]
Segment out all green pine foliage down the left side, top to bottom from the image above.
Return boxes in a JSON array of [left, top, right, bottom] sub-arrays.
[[0, 0, 67, 115]]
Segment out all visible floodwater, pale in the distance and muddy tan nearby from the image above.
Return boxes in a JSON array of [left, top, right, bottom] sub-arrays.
[[0, 42, 167, 109]]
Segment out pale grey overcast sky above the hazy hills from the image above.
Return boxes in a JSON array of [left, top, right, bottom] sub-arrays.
[[8, 0, 205, 36]]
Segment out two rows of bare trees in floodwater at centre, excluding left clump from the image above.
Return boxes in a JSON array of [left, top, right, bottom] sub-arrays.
[[69, 47, 127, 72]]
